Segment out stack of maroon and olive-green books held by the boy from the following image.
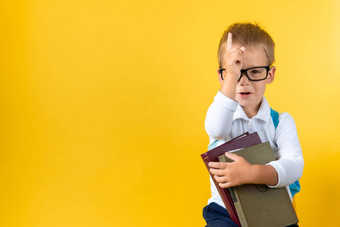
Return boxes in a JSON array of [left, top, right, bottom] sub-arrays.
[[201, 132, 298, 227]]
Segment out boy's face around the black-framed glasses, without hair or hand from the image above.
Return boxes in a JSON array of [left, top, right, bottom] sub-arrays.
[[235, 45, 276, 117]]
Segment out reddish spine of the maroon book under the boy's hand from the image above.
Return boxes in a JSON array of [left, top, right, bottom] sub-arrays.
[[201, 153, 241, 227]]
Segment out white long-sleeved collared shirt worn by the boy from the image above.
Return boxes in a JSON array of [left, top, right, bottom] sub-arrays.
[[205, 92, 304, 207]]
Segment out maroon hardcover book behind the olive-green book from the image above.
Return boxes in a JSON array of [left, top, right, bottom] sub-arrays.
[[201, 132, 262, 226]]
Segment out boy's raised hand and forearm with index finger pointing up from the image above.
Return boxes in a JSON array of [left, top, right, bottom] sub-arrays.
[[220, 33, 246, 100]]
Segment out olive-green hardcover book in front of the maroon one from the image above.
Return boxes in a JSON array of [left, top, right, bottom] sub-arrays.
[[219, 142, 299, 227]]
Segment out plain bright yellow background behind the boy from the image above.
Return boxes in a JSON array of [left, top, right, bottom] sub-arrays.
[[0, 0, 340, 227]]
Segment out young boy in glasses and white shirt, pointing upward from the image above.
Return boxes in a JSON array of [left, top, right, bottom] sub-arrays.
[[203, 23, 304, 226]]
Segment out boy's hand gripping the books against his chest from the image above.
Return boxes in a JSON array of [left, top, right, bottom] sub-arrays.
[[209, 152, 253, 188]]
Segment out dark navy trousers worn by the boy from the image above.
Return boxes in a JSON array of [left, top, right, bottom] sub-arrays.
[[203, 203, 298, 227]]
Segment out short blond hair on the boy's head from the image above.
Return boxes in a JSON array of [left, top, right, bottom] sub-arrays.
[[217, 23, 275, 67]]
